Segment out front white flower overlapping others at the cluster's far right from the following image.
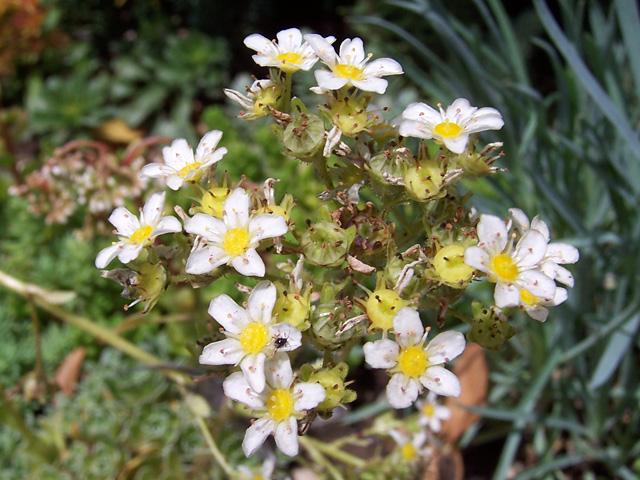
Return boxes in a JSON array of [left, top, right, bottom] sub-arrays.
[[464, 215, 556, 308]]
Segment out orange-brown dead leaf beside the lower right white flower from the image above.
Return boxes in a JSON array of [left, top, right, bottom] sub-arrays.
[[442, 343, 489, 443]]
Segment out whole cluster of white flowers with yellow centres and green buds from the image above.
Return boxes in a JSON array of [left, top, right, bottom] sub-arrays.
[[96, 28, 578, 472]]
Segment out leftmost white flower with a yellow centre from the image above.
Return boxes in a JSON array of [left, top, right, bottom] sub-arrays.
[[96, 192, 182, 268]]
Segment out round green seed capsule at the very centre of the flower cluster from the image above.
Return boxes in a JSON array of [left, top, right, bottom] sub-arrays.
[[300, 222, 356, 267]]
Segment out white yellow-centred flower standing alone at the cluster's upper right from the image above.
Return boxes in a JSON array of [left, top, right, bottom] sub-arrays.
[[400, 98, 504, 153]]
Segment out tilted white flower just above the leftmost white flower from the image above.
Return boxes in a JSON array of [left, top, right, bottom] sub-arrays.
[[140, 130, 227, 190]]
